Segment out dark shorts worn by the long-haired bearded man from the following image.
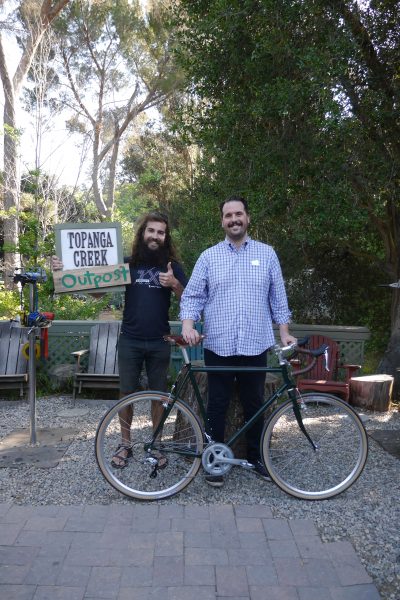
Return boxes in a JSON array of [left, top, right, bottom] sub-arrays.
[[118, 333, 171, 394]]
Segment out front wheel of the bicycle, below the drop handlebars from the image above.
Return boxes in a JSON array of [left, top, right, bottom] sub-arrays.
[[262, 392, 368, 500]]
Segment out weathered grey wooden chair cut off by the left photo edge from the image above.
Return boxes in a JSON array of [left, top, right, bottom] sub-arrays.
[[0, 321, 28, 397]]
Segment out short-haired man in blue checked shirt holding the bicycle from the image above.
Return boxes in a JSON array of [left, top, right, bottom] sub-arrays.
[[180, 196, 296, 487]]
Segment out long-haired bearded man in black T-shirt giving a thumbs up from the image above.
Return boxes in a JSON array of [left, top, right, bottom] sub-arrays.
[[111, 212, 187, 469]]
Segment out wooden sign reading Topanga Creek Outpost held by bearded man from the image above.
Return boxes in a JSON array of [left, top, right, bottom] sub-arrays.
[[53, 223, 130, 293]]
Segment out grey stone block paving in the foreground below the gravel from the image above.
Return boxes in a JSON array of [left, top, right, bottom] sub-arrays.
[[0, 503, 380, 600]]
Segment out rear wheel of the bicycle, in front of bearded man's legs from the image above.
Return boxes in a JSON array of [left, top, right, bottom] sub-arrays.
[[95, 392, 203, 500]]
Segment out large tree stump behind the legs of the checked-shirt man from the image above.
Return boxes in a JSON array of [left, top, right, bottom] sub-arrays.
[[174, 373, 278, 458]]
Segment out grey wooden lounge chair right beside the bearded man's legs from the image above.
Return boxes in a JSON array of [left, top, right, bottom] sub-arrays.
[[72, 321, 121, 402]]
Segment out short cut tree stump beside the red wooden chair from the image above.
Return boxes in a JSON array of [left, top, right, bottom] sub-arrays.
[[350, 375, 393, 412]]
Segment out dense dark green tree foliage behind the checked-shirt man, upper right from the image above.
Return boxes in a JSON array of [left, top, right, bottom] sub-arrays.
[[175, 0, 400, 368]]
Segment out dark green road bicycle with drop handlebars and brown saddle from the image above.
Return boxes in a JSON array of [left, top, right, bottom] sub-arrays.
[[95, 335, 368, 500]]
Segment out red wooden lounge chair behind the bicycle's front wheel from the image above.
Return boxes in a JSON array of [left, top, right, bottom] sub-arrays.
[[296, 335, 361, 402]]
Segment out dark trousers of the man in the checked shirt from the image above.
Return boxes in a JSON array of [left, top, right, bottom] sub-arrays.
[[204, 349, 267, 462]]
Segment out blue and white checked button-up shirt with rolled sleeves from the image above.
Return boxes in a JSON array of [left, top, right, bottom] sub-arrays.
[[180, 237, 291, 356]]
